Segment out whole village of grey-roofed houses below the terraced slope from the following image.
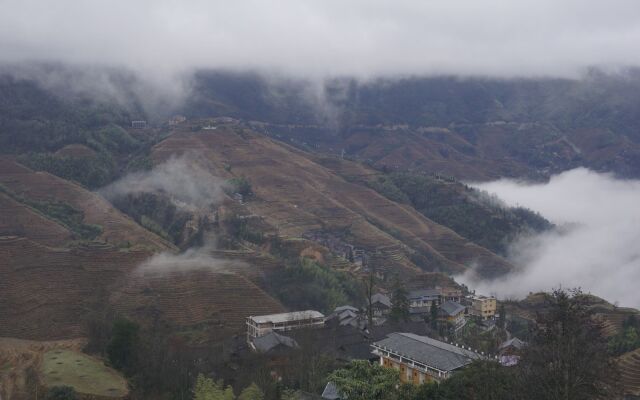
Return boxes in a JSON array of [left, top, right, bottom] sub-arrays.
[[246, 287, 526, 400]]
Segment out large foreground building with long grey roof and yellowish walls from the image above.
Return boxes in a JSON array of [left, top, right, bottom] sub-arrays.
[[372, 333, 484, 385]]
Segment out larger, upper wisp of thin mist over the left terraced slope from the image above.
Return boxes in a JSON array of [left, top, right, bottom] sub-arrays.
[[99, 154, 225, 212]]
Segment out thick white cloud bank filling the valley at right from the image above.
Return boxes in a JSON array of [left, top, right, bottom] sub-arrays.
[[461, 168, 640, 307]]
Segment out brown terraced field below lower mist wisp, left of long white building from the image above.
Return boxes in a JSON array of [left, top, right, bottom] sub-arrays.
[[110, 270, 284, 340]]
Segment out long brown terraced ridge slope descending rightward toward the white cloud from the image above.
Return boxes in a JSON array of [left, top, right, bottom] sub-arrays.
[[153, 126, 511, 276]]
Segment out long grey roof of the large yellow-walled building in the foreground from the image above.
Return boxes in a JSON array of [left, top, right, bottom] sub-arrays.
[[374, 333, 483, 371]]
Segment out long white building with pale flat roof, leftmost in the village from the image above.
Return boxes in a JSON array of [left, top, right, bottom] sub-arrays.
[[247, 310, 325, 342]]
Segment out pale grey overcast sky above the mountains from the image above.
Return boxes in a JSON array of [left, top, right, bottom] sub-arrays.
[[0, 0, 640, 77]]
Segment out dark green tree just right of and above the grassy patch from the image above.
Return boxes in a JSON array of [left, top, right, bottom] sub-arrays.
[[107, 318, 139, 372]]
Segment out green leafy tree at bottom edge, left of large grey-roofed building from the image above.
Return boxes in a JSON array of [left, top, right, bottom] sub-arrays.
[[328, 360, 400, 400]]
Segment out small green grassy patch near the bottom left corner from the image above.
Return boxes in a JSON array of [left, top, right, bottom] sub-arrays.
[[42, 350, 128, 398]]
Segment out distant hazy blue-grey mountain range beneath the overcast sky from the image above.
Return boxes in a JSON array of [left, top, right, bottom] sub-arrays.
[[183, 70, 640, 180]]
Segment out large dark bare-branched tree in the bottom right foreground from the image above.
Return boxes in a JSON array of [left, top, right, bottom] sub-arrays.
[[520, 289, 619, 400]]
